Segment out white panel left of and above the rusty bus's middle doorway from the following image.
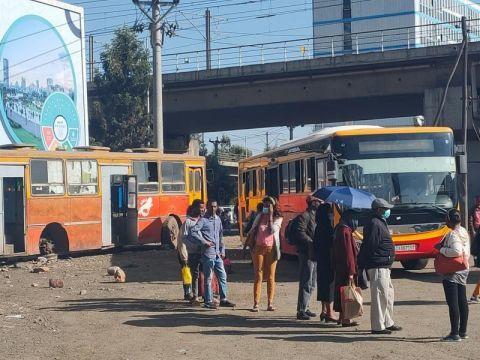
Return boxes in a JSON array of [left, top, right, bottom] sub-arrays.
[[101, 165, 128, 246]]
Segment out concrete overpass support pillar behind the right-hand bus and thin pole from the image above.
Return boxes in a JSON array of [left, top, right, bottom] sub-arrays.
[[423, 86, 480, 206]]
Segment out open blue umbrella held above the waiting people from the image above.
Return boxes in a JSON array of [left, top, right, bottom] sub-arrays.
[[312, 186, 375, 209]]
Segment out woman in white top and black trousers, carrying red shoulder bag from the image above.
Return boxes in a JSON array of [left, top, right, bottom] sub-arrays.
[[435, 209, 470, 341]]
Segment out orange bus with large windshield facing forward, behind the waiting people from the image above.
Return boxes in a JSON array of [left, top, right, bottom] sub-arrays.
[[239, 126, 458, 269]]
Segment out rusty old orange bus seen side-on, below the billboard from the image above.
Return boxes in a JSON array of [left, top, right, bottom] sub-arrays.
[[0, 145, 206, 256]]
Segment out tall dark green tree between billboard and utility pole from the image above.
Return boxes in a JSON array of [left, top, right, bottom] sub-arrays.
[[90, 27, 153, 151]]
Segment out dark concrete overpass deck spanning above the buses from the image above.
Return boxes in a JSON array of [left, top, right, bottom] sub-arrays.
[[164, 43, 480, 135]]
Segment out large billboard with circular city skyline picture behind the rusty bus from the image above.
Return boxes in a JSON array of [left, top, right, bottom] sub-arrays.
[[0, 0, 88, 150]]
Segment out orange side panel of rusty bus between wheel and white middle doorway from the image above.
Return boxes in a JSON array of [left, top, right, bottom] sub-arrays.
[[65, 196, 102, 251]]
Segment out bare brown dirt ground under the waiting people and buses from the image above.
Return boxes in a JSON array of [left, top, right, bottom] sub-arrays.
[[0, 237, 480, 360]]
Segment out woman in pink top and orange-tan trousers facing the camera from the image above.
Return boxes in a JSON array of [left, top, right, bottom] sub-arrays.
[[249, 196, 283, 312]]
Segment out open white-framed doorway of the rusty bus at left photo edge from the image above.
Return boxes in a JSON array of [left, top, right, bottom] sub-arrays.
[[0, 166, 25, 255]]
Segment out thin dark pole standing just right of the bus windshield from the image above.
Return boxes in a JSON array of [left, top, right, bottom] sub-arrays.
[[460, 16, 468, 229]]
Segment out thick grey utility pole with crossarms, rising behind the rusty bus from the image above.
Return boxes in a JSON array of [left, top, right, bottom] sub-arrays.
[[132, 0, 180, 153]]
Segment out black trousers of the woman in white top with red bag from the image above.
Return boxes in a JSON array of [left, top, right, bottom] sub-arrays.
[[443, 280, 468, 335]]
